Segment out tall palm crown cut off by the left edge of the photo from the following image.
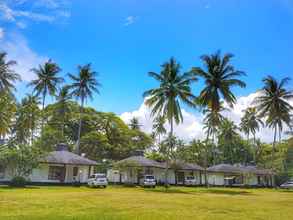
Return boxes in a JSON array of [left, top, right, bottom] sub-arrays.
[[0, 52, 21, 93]]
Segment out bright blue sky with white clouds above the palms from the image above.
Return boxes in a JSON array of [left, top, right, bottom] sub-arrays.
[[0, 0, 293, 142]]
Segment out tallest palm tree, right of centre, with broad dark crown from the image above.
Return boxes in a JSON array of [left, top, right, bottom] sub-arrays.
[[191, 51, 246, 185]]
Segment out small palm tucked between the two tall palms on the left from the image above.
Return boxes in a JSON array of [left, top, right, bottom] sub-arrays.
[[56, 86, 71, 137]]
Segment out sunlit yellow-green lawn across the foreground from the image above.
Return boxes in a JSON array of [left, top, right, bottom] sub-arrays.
[[0, 186, 293, 220]]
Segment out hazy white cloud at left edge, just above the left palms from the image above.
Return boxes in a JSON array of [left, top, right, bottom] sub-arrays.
[[0, 34, 48, 81]]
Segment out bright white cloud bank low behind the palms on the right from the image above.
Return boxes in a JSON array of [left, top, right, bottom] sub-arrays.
[[120, 92, 293, 142]]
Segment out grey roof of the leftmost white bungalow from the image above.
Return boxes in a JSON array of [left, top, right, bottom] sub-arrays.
[[40, 150, 97, 166]]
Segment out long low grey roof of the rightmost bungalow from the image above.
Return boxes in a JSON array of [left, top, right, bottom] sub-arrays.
[[207, 164, 272, 175]]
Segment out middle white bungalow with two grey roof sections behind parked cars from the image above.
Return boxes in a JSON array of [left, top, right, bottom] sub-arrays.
[[107, 155, 203, 185]]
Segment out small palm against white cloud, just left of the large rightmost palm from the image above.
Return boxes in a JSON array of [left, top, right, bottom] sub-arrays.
[[240, 107, 263, 143]]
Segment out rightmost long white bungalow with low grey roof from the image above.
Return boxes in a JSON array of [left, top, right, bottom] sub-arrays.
[[207, 164, 273, 186]]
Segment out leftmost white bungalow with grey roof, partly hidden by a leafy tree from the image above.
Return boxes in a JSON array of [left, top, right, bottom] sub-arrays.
[[0, 144, 97, 183]]
